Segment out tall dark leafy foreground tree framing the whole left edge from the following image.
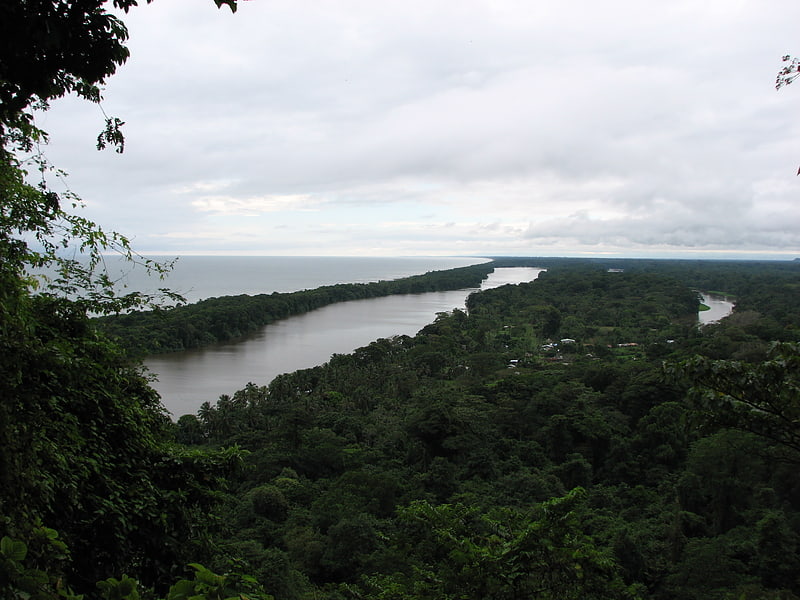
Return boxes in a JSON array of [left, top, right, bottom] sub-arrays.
[[0, 0, 241, 589]]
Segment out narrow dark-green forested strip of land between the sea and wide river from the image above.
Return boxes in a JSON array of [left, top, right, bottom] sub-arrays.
[[96, 262, 494, 355]]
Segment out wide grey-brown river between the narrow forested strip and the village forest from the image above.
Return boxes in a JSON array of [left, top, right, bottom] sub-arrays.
[[145, 267, 543, 417]]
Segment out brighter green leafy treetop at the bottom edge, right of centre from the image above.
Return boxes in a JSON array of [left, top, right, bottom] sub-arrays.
[[366, 489, 635, 600]]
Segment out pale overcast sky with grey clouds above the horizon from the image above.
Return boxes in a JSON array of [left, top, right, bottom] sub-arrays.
[[37, 0, 800, 259]]
